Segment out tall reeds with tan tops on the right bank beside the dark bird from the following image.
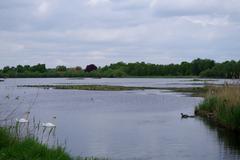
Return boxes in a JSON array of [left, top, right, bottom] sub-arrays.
[[195, 85, 240, 131]]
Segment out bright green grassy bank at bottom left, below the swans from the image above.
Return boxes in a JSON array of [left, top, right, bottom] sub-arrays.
[[0, 127, 106, 160]]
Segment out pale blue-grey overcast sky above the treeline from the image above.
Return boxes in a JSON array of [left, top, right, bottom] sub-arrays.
[[0, 0, 240, 67]]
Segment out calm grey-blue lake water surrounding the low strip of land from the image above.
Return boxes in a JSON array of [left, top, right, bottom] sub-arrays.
[[0, 78, 240, 160]]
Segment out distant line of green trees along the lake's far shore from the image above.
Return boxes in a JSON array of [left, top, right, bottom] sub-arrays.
[[0, 59, 240, 78]]
